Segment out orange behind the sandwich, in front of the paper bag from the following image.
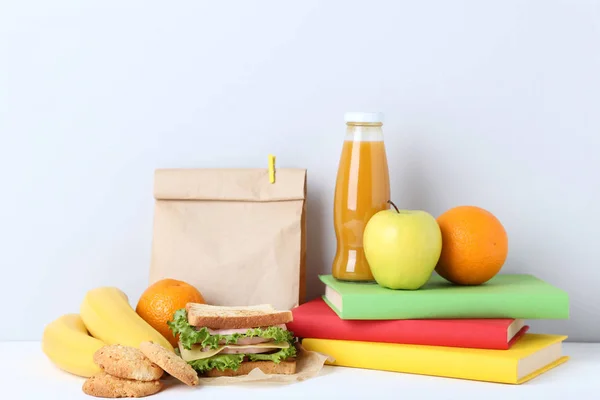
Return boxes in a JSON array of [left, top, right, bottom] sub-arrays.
[[135, 279, 205, 346]]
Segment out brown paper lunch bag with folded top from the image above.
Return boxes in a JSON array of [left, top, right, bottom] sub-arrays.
[[150, 168, 306, 310]]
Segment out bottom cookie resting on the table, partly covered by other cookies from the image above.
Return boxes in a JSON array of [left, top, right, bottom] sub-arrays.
[[82, 372, 163, 398]]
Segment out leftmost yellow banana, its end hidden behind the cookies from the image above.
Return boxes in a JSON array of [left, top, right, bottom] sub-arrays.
[[42, 314, 105, 378]]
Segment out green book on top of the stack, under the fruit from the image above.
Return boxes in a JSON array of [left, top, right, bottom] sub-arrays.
[[319, 274, 569, 320]]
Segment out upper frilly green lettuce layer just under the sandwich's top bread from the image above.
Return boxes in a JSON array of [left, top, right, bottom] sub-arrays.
[[167, 308, 294, 350]]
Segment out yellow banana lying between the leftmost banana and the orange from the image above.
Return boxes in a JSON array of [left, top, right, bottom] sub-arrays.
[[79, 287, 175, 352]]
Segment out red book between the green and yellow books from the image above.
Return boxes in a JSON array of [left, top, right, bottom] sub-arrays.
[[287, 298, 529, 350]]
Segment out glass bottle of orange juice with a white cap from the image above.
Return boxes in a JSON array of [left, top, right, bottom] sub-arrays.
[[332, 112, 390, 281]]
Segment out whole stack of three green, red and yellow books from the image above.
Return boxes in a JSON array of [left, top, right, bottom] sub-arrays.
[[288, 274, 569, 384]]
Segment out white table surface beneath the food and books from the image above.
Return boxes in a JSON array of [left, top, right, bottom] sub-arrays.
[[0, 342, 600, 400]]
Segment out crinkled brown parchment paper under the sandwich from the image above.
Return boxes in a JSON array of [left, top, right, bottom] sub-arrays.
[[199, 344, 334, 385]]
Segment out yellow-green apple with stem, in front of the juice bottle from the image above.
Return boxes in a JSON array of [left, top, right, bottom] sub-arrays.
[[363, 201, 442, 290]]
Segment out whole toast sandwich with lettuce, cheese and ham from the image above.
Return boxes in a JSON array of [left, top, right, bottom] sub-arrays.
[[168, 303, 297, 377]]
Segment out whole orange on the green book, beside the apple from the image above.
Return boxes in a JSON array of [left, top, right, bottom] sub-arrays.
[[435, 206, 508, 285]]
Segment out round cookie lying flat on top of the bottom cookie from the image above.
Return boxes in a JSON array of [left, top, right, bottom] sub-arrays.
[[94, 344, 164, 382]]
